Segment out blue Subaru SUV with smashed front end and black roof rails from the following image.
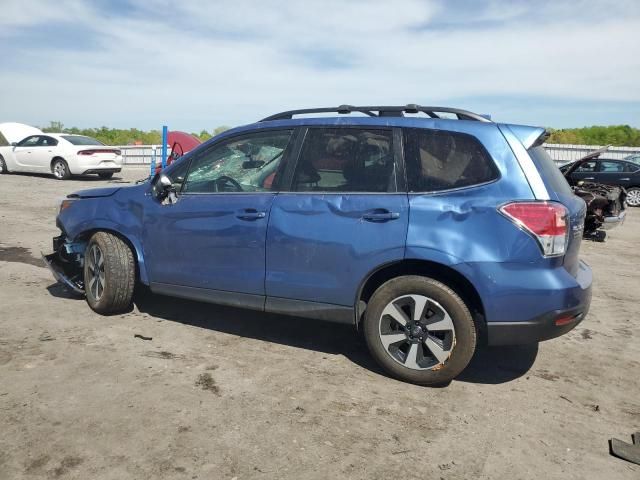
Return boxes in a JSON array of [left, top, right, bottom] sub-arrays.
[[45, 105, 592, 385]]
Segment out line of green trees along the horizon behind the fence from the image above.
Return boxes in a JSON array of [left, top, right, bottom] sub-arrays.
[[41, 122, 640, 147]]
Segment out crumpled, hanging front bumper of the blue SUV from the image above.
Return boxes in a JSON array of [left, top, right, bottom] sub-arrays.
[[42, 235, 86, 295]]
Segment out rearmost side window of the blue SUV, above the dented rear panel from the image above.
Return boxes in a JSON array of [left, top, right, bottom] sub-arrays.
[[405, 128, 499, 192]]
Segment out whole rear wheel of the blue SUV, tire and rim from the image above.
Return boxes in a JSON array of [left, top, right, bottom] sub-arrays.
[[364, 276, 477, 385]]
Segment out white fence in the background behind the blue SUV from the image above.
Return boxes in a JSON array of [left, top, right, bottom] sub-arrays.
[[118, 143, 640, 165]]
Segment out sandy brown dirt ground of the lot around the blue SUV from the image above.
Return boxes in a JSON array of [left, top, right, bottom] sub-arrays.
[[0, 169, 640, 480]]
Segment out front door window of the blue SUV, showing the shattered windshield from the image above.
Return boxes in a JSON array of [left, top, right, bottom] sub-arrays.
[[182, 130, 292, 193]]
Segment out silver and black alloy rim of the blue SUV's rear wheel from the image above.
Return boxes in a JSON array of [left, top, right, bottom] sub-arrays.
[[379, 295, 456, 370]]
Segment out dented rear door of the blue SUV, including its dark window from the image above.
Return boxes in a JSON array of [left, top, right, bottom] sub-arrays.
[[265, 126, 409, 308]]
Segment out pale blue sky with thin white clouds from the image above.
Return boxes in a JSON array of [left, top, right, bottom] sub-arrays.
[[0, 0, 640, 132]]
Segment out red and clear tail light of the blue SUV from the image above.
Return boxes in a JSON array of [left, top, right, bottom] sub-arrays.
[[500, 202, 569, 257]]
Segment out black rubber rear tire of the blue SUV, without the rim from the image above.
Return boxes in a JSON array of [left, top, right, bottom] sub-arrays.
[[363, 276, 477, 386]]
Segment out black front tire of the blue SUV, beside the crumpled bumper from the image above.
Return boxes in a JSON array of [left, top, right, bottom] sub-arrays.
[[84, 232, 136, 315]]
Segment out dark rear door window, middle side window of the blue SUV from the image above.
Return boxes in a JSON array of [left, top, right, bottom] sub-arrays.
[[293, 128, 396, 193]]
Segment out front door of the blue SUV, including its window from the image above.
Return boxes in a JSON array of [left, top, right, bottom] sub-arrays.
[[144, 130, 292, 306]]
